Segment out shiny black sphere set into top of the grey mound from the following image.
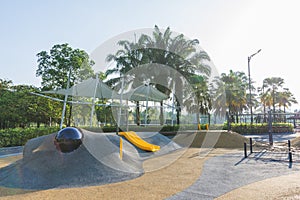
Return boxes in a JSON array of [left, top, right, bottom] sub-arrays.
[[54, 127, 83, 153]]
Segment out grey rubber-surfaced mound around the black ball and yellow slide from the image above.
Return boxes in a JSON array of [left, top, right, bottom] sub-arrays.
[[0, 130, 181, 190]]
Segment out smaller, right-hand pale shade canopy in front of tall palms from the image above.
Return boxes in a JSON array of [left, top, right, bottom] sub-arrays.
[[123, 85, 168, 102]]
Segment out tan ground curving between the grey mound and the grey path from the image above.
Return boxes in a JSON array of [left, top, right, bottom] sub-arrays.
[[0, 148, 233, 200]]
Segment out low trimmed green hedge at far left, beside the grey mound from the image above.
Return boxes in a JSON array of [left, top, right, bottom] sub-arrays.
[[0, 127, 59, 147]]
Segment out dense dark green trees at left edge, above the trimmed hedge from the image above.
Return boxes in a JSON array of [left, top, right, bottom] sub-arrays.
[[0, 83, 62, 129]]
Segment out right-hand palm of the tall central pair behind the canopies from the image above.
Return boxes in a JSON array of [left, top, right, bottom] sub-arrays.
[[141, 26, 211, 124]]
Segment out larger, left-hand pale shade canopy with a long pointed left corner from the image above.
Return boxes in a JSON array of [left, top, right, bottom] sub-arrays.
[[43, 78, 113, 99]]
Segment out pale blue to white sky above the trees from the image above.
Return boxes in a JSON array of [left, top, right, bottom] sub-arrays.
[[0, 0, 300, 109]]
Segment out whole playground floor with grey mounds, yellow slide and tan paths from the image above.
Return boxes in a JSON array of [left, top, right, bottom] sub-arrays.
[[0, 130, 300, 199]]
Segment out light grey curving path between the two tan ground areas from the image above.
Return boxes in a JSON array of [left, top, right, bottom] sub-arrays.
[[168, 152, 300, 200]]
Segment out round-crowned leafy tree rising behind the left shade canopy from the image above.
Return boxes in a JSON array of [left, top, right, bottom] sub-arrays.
[[36, 44, 94, 126]]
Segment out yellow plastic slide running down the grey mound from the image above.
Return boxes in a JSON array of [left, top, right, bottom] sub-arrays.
[[119, 131, 160, 152]]
